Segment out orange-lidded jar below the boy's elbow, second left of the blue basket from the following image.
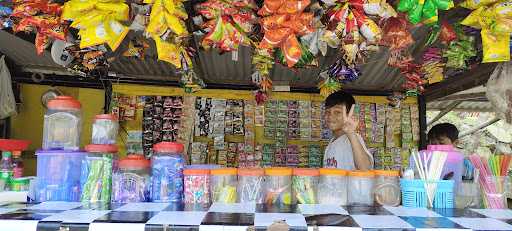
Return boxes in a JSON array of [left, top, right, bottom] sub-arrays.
[[347, 171, 375, 206]]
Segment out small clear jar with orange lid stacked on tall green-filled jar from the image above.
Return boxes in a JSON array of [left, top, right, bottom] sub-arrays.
[[92, 114, 119, 144]]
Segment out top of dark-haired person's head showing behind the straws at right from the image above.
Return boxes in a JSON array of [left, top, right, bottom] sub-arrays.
[[427, 123, 459, 146]]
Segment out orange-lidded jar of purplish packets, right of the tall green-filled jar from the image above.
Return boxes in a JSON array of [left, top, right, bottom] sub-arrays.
[[112, 155, 151, 203]]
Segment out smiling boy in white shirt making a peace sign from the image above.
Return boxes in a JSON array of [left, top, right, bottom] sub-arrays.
[[324, 91, 373, 170]]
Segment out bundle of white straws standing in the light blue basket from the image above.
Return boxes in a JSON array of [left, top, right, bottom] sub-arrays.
[[412, 150, 448, 208]]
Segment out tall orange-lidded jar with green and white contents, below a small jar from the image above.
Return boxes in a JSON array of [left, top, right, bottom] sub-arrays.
[[80, 144, 118, 203]]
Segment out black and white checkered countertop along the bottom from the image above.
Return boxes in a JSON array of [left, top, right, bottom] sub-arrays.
[[0, 202, 512, 231]]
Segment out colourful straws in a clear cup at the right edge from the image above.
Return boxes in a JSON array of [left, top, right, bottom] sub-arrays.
[[469, 154, 512, 209]]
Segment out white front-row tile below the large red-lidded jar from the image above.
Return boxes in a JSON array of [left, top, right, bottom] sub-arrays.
[[147, 211, 206, 225]]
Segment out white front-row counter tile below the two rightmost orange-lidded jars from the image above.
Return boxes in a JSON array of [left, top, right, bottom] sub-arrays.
[[352, 215, 414, 229]]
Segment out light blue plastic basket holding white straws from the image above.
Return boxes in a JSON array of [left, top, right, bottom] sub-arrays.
[[400, 179, 455, 208]]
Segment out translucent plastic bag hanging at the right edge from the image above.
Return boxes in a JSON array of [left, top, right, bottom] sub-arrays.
[[486, 62, 512, 124]]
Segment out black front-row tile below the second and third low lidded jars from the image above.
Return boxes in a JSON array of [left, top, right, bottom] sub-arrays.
[[201, 212, 254, 226]]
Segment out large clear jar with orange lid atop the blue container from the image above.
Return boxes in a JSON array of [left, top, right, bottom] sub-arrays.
[[43, 96, 82, 151]]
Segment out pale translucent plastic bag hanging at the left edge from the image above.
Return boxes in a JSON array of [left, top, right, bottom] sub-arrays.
[[0, 56, 16, 119]]
